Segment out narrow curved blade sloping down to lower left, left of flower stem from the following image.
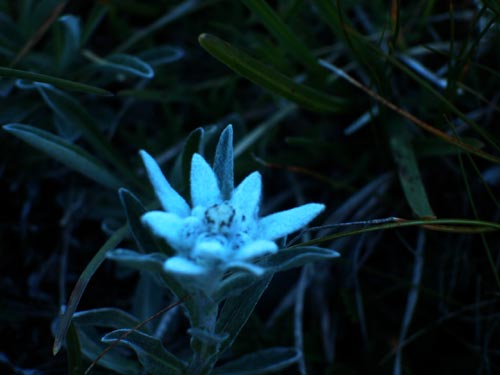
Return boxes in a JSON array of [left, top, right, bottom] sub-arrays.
[[52, 226, 128, 355]]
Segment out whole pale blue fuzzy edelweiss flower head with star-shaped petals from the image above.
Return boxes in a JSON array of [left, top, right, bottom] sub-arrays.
[[140, 125, 324, 288]]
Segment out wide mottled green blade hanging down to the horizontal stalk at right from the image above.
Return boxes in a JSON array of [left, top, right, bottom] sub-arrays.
[[388, 118, 435, 218]]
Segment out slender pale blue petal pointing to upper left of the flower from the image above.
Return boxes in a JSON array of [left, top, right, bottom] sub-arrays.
[[139, 150, 190, 217]]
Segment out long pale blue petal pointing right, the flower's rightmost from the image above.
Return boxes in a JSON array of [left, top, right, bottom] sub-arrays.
[[258, 203, 325, 240]]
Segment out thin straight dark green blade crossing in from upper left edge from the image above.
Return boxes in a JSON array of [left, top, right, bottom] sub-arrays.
[[0, 67, 113, 96]]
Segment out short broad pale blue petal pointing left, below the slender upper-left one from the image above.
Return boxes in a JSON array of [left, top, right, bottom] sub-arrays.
[[141, 211, 186, 251]]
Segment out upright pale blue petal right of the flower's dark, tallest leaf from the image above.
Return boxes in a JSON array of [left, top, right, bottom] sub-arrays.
[[231, 172, 262, 225]]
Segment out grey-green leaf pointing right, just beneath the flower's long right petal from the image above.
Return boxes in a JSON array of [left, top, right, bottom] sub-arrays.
[[257, 246, 340, 273]]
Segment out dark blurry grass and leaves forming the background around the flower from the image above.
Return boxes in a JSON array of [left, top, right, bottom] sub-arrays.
[[0, 0, 500, 374]]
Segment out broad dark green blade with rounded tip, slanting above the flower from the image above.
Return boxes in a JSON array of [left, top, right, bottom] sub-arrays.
[[198, 34, 347, 113]]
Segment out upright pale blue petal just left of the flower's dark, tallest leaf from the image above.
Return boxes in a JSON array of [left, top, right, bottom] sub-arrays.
[[191, 154, 221, 208]]
